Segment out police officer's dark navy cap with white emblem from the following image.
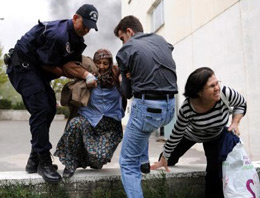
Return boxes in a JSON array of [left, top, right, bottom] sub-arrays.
[[76, 4, 98, 31]]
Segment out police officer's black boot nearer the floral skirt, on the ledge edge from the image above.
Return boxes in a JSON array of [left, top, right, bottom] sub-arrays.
[[37, 152, 61, 183]]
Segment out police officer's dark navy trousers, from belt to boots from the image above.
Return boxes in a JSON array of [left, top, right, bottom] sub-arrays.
[[7, 58, 56, 153]]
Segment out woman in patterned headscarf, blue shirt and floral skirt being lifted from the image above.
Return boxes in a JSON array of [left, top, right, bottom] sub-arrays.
[[54, 49, 124, 178]]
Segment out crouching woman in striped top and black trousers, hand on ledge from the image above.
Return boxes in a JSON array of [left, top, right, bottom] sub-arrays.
[[151, 67, 246, 198]]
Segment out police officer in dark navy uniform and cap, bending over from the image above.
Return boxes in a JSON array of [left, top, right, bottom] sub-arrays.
[[5, 4, 98, 183]]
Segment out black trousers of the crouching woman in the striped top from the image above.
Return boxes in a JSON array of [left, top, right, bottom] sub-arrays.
[[164, 135, 224, 198]]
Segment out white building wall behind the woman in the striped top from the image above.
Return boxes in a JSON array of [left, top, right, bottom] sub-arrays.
[[122, 0, 260, 160]]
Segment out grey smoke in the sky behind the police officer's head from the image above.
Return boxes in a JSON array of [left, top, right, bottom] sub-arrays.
[[49, 0, 121, 57]]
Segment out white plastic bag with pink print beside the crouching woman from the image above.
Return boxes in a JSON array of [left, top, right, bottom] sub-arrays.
[[222, 142, 260, 198]]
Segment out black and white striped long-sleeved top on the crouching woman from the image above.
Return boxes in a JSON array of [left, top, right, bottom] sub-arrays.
[[163, 86, 246, 158]]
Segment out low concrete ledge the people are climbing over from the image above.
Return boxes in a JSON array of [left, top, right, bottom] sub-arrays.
[[0, 162, 260, 198]]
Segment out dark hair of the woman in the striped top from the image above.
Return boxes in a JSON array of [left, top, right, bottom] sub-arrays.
[[183, 67, 214, 98]]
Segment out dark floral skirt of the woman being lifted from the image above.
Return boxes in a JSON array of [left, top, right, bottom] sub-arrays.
[[54, 116, 123, 170]]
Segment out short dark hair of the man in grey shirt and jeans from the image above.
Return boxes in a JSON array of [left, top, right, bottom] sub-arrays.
[[114, 15, 144, 37]]
